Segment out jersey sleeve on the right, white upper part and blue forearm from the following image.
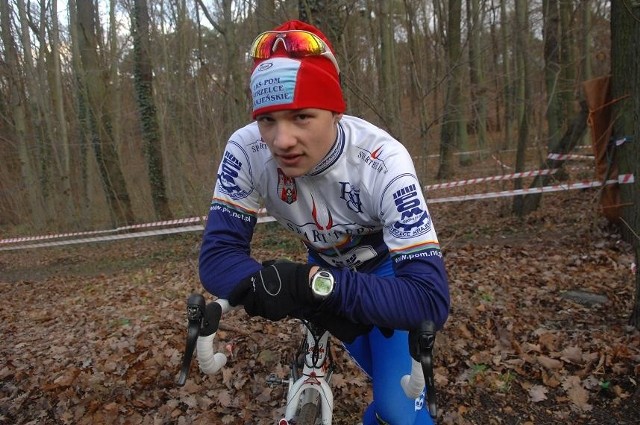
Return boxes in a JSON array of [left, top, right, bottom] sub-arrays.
[[320, 164, 450, 329]]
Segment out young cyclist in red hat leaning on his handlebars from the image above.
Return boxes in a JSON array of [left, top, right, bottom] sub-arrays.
[[200, 21, 449, 425]]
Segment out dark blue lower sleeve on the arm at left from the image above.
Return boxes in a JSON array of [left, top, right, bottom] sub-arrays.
[[199, 202, 262, 298]]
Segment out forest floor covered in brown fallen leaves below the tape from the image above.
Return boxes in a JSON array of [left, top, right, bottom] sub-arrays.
[[0, 161, 640, 424]]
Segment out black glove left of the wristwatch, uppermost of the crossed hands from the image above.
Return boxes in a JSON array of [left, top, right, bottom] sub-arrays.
[[229, 261, 319, 320]]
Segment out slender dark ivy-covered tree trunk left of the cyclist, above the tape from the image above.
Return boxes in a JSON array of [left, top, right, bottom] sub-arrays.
[[131, 0, 173, 220]]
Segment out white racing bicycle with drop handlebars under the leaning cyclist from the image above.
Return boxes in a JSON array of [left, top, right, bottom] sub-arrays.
[[178, 293, 436, 425]]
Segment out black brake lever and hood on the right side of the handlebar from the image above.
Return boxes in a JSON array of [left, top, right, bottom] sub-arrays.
[[409, 320, 437, 419]]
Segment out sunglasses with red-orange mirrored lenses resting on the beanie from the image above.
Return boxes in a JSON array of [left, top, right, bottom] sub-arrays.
[[249, 30, 340, 74]]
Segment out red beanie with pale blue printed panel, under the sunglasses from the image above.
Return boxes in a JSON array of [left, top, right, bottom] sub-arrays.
[[250, 21, 346, 119]]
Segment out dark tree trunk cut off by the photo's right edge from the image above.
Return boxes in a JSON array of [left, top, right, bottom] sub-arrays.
[[611, 1, 640, 329]]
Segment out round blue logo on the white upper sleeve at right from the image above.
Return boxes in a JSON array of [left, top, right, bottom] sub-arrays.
[[389, 184, 431, 239]]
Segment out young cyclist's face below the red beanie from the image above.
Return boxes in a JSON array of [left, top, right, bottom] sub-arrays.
[[256, 108, 342, 177]]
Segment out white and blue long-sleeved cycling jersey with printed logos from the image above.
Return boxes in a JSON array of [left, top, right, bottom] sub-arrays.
[[200, 115, 449, 329]]
